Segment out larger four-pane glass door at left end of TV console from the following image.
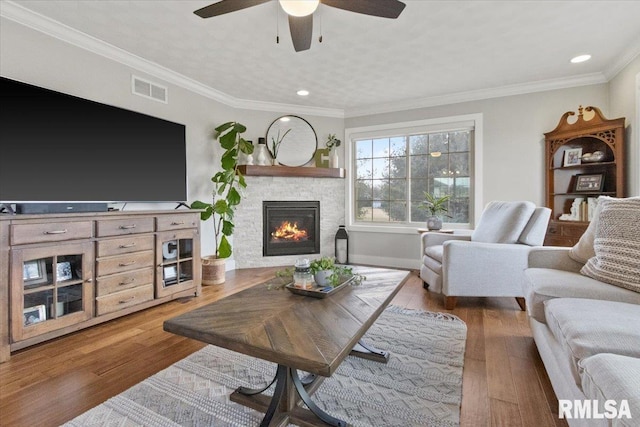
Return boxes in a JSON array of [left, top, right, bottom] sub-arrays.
[[11, 242, 93, 341]]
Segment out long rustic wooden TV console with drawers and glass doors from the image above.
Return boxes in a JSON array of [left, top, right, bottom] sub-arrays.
[[0, 210, 201, 362]]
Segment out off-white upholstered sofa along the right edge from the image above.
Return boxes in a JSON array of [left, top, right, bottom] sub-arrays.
[[524, 200, 640, 427]]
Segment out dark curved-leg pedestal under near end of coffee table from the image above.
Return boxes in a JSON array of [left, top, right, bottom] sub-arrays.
[[230, 365, 347, 427]]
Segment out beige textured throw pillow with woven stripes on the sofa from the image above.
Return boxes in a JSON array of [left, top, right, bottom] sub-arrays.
[[580, 197, 640, 292]]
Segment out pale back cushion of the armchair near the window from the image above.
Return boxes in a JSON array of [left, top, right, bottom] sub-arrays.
[[471, 201, 536, 243]]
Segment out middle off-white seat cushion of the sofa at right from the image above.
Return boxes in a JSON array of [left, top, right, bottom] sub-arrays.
[[545, 298, 640, 386]]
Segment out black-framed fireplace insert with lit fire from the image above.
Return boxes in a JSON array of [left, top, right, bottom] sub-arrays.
[[262, 201, 320, 256]]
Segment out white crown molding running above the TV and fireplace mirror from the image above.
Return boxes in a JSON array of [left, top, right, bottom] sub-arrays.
[[0, 1, 344, 118]]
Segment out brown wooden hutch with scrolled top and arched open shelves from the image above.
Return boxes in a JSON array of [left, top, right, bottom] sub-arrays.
[[544, 106, 625, 246]]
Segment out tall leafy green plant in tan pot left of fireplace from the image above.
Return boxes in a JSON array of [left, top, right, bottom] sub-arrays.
[[191, 122, 253, 285]]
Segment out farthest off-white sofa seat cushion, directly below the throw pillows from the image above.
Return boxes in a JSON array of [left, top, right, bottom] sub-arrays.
[[524, 268, 640, 323]]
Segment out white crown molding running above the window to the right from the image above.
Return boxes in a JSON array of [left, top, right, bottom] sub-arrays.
[[345, 73, 608, 118]]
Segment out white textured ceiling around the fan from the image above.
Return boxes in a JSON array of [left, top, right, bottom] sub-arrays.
[[3, 0, 640, 116]]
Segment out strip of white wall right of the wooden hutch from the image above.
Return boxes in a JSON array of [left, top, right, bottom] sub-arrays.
[[607, 56, 640, 196]]
